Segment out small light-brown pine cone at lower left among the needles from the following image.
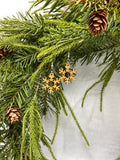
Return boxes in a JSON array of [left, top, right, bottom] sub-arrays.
[[6, 106, 20, 124]]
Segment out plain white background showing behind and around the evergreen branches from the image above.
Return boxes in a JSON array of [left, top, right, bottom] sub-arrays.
[[0, 0, 120, 160]]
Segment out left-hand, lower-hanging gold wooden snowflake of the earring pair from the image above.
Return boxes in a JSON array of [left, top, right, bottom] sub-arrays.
[[43, 72, 60, 94]]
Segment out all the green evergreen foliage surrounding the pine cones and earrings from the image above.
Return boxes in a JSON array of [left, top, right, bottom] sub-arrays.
[[0, 0, 120, 160]]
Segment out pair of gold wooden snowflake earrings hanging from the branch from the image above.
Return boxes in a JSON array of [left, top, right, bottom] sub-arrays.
[[43, 52, 77, 94]]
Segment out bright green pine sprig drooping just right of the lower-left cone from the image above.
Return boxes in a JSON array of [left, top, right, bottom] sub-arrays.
[[21, 96, 42, 160]]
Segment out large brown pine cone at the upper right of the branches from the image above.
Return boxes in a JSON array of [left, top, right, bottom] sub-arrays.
[[88, 8, 108, 35]]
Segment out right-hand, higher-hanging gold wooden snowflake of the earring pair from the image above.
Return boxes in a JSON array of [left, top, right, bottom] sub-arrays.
[[59, 63, 77, 84]]
